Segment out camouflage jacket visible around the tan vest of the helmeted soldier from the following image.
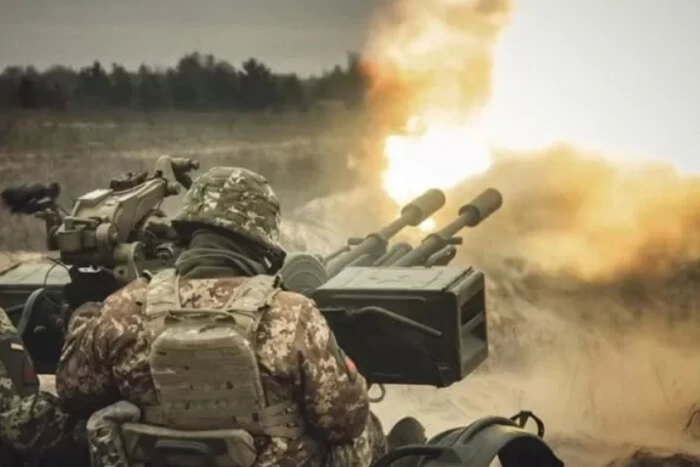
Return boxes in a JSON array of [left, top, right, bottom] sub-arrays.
[[56, 278, 370, 466]]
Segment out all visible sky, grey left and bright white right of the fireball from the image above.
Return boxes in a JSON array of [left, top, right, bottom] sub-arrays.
[[0, 0, 700, 171]]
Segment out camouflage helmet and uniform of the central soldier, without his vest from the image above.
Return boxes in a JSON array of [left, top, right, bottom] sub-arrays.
[[56, 167, 386, 466]]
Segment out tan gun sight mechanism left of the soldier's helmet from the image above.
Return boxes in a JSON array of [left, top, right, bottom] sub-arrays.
[[2, 156, 199, 286]]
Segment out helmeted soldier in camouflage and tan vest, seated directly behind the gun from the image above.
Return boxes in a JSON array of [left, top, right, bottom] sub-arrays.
[[56, 167, 394, 466]]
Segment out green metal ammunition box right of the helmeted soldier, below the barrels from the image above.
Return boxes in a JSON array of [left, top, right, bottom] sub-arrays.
[[311, 267, 488, 387]]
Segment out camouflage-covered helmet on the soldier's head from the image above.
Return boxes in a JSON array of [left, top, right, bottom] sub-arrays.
[[172, 167, 283, 251]]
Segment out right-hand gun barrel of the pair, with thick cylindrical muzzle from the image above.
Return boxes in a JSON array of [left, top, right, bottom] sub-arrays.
[[392, 188, 503, 266]]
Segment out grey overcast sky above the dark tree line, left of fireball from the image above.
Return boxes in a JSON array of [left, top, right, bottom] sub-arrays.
[[0, 0, 375, 74]]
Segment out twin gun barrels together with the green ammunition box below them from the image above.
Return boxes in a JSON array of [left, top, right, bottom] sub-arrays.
[[280, 189, 502, 390]]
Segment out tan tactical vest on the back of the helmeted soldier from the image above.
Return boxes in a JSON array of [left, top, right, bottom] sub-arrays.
[[145, 269, 303, 438]]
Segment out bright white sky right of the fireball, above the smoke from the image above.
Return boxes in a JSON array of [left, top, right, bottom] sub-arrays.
[[484, 0, 700, 173]]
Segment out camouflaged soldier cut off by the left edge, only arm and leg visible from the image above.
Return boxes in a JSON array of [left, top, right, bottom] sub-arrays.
[[0, 308, 88, 466]]
